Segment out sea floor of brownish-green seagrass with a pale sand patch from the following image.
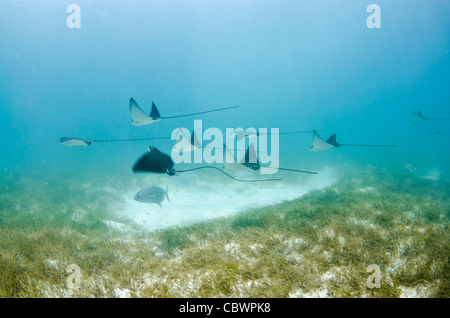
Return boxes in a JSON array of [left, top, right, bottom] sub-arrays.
[[0, 166, 450, 298]]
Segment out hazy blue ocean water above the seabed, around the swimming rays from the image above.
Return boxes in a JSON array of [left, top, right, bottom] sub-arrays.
[[0, 0, 450, 179]]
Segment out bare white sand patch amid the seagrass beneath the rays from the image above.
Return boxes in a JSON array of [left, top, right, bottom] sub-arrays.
[[110, 168, 335, 231]]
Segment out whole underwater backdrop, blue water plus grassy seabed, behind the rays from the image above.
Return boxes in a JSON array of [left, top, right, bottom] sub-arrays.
[[0, 0, 450, 298]]
